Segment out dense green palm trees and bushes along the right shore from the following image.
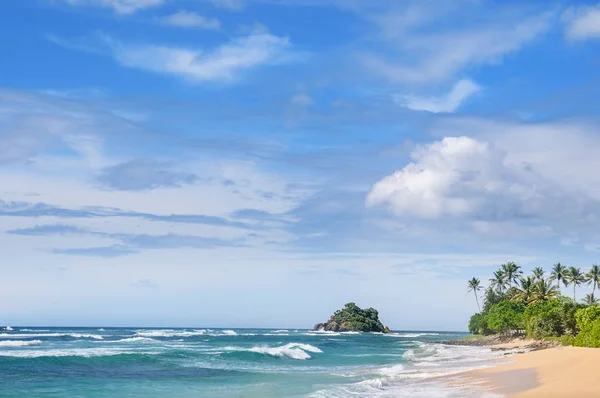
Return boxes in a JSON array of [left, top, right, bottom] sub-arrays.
[[467, 262, 600, 347]]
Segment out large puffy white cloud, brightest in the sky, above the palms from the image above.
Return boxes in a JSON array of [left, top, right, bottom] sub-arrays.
[[367, 136, 558, 220]]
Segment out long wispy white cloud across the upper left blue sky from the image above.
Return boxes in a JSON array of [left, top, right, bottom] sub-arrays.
[[89, 34, 292, 83]]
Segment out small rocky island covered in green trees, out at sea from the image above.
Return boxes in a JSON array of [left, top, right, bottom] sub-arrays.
[[314, 303, 391, 333]]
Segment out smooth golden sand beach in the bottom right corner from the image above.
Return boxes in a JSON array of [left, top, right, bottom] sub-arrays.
[[461, 344, 600, 398]]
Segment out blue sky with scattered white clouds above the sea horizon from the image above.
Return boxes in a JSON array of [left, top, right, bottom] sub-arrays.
[[0, 0, 600, 330]]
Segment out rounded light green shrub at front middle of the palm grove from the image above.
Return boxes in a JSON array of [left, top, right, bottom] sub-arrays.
[[523, 300, 565, 339]]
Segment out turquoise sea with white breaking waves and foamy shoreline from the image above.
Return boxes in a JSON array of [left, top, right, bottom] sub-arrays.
[[0, 327, 504, 398]]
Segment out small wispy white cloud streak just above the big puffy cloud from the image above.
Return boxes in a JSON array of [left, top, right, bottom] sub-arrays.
[[399, 79, 481, 113]]
